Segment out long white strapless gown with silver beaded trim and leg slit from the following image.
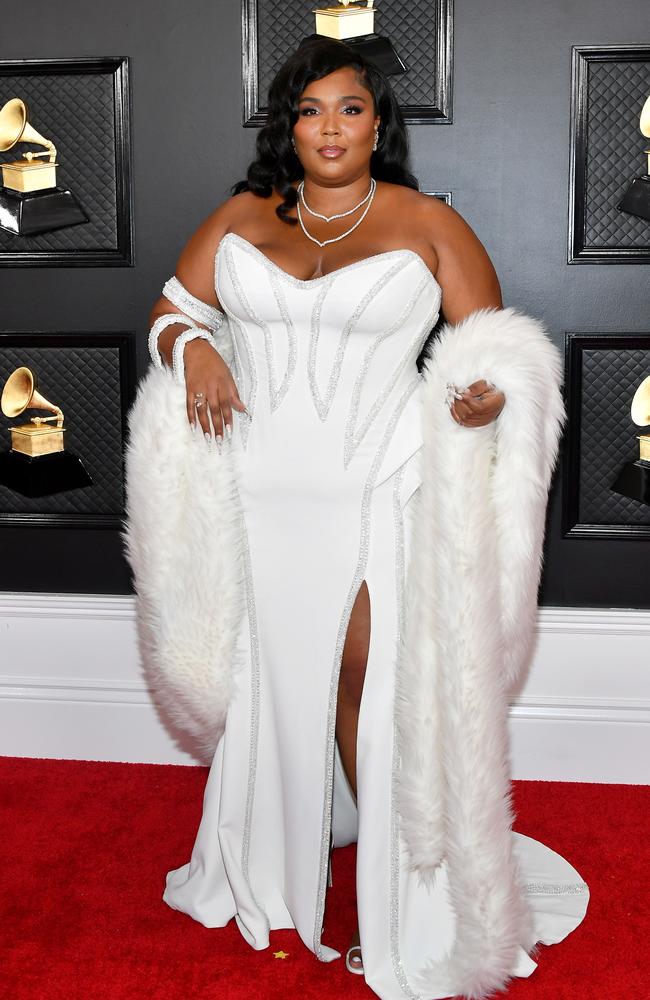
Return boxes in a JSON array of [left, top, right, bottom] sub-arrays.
[[163, 234, 589, 1000]]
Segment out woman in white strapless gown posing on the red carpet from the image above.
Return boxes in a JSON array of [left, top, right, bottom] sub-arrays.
[[130, 40, 586, 1000]]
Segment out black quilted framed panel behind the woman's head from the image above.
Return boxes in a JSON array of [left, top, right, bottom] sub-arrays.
[[242, 0, 453, 126]]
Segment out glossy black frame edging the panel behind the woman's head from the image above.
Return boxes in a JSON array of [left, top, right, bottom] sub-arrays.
[[241, 0, 454, 128]]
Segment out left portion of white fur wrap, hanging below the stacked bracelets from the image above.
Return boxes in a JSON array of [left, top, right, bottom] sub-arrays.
[[122, 365, 246, 763]]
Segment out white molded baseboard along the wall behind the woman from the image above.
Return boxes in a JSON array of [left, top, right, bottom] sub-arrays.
[[0, 593, 650, 784]]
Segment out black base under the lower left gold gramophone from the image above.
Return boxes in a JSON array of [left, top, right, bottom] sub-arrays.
[[0, 451, 92, 498]]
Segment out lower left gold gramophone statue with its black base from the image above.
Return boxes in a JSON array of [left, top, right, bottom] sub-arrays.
[[0, 367, 92, 497]]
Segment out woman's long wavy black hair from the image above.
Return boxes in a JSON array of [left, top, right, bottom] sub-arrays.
[[232, 36, 419, 225]]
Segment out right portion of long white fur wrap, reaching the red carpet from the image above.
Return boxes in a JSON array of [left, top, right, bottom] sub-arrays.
[[396, 309, 565, 997]]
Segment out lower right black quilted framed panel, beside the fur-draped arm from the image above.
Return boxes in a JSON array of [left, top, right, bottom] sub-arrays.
[[562, 333, 650, 538]]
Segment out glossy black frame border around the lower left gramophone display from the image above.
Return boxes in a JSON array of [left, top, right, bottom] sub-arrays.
[[0, 330, 137, 530]]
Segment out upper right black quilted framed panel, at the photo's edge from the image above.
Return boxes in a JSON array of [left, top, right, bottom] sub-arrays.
[[568, 45, 650, 264]]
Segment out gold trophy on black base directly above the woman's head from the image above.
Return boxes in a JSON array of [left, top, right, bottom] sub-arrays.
[[309, 0, 406, 76]]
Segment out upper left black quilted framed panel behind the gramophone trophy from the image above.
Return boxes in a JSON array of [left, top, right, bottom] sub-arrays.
[[0, 57, 133, 267]]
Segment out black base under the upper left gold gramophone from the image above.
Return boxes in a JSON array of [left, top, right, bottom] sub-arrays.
[[0, 187, 89, 236]]
